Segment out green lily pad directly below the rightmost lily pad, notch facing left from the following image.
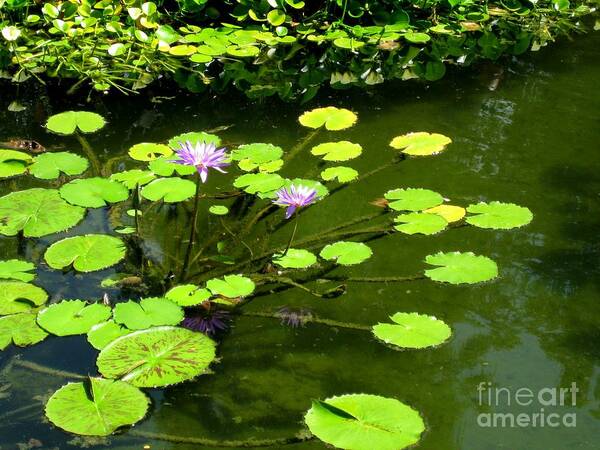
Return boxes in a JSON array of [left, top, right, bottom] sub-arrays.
[[425, 252, 498, 284]]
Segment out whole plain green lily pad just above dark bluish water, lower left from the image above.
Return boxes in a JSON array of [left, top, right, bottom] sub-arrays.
[[37, 300, 112, 336]]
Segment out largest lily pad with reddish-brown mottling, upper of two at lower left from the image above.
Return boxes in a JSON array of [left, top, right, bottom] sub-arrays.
[[97, 327, 216, 387]]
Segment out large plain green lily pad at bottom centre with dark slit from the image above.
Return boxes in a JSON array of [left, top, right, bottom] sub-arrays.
[[304, 394, 425, 450]]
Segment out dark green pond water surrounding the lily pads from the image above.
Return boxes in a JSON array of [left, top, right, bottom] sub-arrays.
[[0, 34, 600, 450]]
